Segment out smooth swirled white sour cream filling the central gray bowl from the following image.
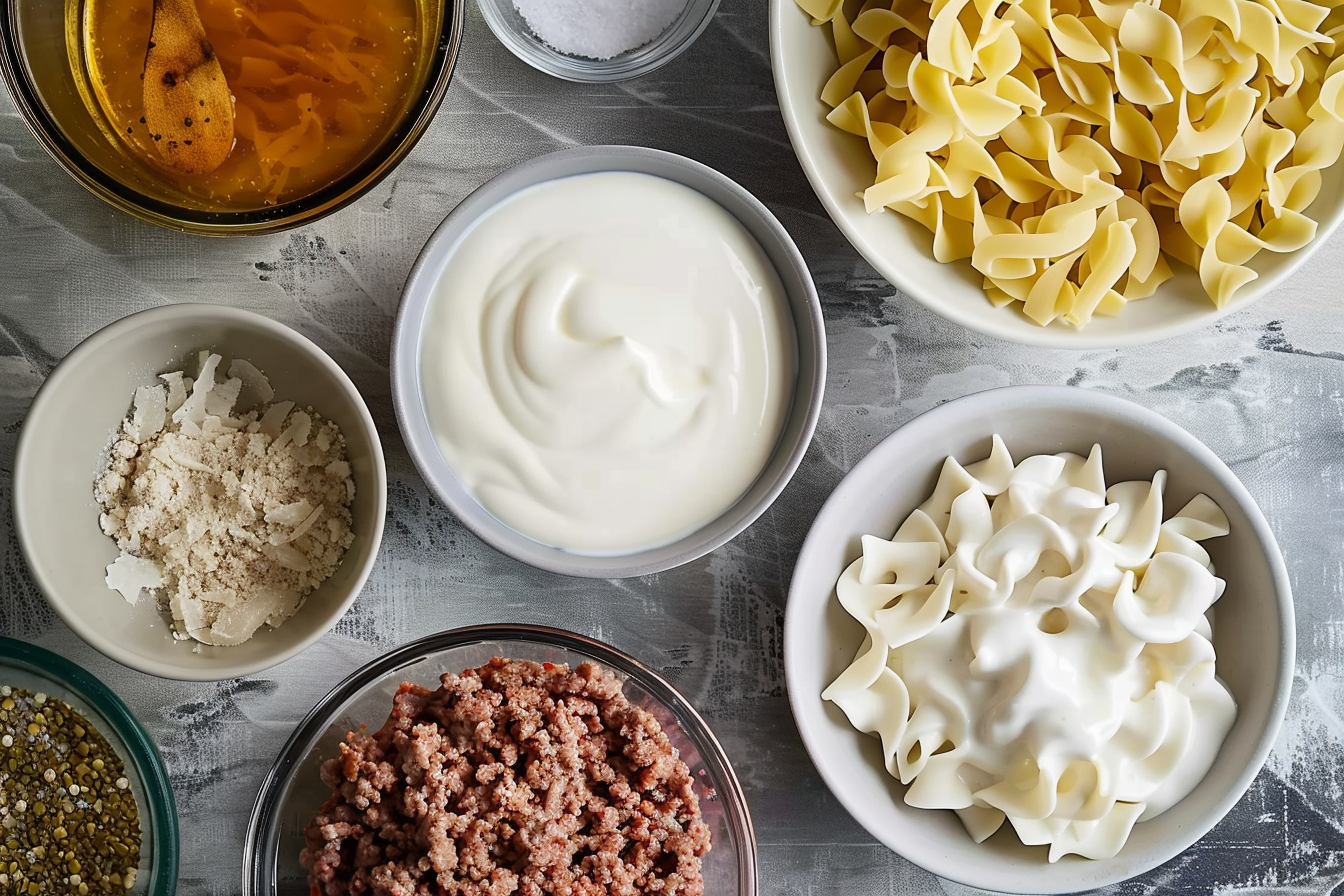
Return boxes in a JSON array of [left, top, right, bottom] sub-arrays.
[[421, 172, 797, 555]]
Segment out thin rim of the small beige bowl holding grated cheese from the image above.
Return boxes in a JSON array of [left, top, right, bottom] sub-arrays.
[[12, 302, 387, 681]]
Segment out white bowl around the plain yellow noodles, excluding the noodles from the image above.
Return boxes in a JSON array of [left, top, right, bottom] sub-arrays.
[[770, 0, 1344, 349]]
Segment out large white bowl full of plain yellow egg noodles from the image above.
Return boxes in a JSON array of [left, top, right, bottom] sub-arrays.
[[770, 0, 1344, 348]]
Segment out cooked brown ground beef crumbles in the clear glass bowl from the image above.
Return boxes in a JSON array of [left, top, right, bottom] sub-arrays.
[[302, 657, 710, 896]]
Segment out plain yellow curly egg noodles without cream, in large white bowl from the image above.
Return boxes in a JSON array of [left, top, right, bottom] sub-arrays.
[[797, 0, 1344, 326]]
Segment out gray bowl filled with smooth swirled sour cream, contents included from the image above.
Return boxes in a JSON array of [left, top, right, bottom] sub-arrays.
[[391, 146, 825, 578]]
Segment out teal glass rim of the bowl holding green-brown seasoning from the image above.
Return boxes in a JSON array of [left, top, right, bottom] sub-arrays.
[[0, 637, 181, 896]]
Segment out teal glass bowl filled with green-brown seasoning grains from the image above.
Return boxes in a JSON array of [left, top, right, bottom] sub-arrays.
[[0, 638, 177, 896]]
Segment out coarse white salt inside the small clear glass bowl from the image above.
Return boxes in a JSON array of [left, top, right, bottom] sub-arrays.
[[513, 0, 687, 59]]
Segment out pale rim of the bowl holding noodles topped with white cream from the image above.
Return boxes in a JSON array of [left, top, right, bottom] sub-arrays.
[[784, 386, 1297, 893]]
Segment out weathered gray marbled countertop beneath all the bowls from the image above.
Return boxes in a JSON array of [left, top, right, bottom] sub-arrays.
[[0, 0, 1344, 896]]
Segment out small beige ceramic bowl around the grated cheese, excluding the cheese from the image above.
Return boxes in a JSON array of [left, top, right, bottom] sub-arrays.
[[13, 305, 387, 681]]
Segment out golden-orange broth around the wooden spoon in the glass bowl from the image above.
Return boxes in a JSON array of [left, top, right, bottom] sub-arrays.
[[78, 0, 442, 211]]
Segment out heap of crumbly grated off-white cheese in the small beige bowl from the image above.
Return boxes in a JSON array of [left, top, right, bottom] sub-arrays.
[[94, 353, 355, 646]]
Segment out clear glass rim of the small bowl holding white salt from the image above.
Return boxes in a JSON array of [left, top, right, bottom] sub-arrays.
[[476, 0, 719, 83]]
